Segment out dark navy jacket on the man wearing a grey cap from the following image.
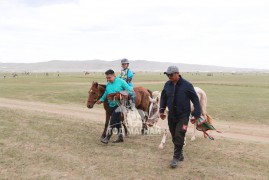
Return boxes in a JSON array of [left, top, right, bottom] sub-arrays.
[[159, 76, 201, 119]]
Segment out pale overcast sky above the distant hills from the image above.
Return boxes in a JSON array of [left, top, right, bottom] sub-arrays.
[[0, 0, 269, 69]]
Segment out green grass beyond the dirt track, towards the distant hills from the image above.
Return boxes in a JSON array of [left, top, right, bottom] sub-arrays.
[[0, 72, 269, 125]]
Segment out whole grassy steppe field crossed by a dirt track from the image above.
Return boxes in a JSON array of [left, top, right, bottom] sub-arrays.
[[0, 72, 269, 180]]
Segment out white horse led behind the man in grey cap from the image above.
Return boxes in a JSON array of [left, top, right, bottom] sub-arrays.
[[147, 87, 213, 149]]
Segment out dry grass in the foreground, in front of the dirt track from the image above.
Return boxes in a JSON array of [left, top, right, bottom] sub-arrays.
[[0, 108, 269, 179]]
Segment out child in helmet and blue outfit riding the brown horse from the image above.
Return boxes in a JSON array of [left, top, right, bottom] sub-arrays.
[[119, 58, 136, 110]]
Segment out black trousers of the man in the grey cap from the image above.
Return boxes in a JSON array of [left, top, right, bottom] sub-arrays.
[[168, 117, 189, 146]]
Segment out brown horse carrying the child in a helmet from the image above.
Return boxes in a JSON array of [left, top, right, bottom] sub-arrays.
[[87, 82, 152, 139]]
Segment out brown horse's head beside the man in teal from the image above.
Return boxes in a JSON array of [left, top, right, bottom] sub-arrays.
[[87, 82, 104, 108]]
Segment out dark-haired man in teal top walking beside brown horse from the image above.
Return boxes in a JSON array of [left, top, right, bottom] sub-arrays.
[[97, 69, 133, 144]]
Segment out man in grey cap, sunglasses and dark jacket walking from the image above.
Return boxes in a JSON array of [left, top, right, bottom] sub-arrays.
[[159, 66, 201, 168]]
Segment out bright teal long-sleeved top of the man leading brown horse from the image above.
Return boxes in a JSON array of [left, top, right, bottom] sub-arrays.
[[100, 77, 133, 107]]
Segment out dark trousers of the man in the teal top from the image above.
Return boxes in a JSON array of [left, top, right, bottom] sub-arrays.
[[108, 106, 122, 135]]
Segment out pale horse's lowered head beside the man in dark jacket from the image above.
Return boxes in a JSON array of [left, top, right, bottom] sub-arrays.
[[147, 92, 160, 127]]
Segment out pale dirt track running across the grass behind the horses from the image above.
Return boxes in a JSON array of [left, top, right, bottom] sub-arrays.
[[0, 98, 269, 143]]
